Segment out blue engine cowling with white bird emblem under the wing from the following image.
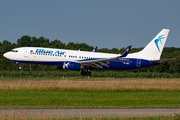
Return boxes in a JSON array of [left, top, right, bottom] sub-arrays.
[[63, 62, 81, 71]]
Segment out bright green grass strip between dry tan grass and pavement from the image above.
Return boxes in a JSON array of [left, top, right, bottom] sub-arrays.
[[0, 89, 180, 108]]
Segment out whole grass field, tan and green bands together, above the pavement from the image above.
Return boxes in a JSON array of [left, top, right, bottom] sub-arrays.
[[0, 80, 180, 108]]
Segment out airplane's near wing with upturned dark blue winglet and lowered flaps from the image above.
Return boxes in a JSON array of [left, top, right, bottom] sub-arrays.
[[79, 46, 131, 69]]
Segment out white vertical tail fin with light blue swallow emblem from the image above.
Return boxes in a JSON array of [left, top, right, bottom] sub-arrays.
[[134, 29, 169, 60]]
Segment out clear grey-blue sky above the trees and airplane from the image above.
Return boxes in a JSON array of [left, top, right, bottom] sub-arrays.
[[0, 0, 180, 49]]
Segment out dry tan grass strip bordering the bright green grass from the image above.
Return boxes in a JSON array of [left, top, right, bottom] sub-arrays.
[[0, 80, 180, 91]]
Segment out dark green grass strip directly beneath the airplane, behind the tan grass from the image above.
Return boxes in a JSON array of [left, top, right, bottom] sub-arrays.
[[0, 70, 180, 79]]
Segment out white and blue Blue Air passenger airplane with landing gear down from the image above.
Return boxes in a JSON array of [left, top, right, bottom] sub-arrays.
[[3, 29, 172, 76]]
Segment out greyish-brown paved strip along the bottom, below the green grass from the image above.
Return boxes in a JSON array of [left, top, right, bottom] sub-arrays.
[[0, 108, 180, 118]]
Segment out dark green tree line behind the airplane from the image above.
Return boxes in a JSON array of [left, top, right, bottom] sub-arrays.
[[0, 35, 180, 73]]
